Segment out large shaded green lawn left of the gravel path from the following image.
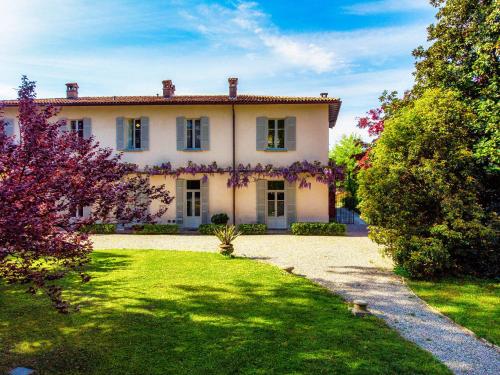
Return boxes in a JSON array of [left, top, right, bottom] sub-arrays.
[[0, 250, 449, 375]]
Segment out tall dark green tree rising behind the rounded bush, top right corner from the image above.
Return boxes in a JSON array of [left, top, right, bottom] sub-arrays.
[[413, 0, 500, 173]]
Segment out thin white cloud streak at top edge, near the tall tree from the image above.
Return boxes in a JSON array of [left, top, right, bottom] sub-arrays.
[[344, 0, 432, 15]]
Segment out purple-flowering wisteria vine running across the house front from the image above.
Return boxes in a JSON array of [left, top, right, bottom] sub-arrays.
[[144, 160, 343, 189]]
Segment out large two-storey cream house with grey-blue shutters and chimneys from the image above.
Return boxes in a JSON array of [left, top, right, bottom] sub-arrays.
[[3, 78, 341, 229]]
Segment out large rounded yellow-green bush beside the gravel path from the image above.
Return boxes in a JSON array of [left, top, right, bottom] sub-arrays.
[[359, 89, 500, 277]]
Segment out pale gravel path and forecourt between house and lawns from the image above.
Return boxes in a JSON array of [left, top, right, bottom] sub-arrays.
[[93, 231, 500, 375]]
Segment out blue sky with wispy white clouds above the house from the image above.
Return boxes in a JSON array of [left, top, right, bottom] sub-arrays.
[[0, 0, 435, 144]]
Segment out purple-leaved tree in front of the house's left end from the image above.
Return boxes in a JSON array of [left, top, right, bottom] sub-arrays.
[[0, 77, 173, 312]]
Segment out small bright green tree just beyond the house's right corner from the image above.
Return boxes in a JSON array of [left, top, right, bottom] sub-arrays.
[[329, 134, 365, 210]]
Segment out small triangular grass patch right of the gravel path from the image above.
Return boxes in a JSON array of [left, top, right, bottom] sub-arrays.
[[408, 278, 500, 345]]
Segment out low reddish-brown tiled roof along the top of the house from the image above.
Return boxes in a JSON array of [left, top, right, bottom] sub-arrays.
[[0, 95, 342, 127]]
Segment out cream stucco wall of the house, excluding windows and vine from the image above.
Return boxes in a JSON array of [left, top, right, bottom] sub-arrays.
[[4, 104, 329, 228]]
